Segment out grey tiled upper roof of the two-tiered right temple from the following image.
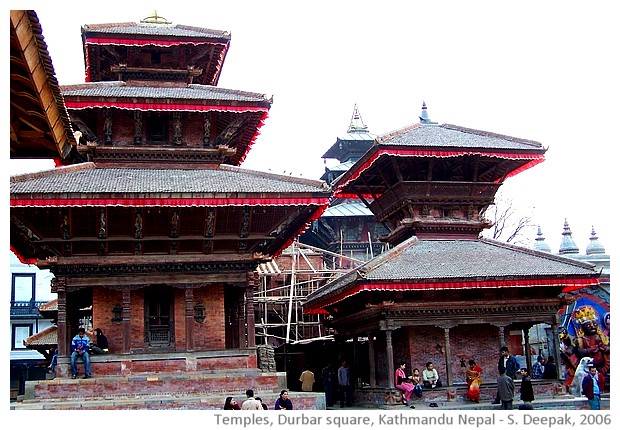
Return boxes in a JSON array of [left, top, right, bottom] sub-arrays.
[[377, 124, 543, 151]]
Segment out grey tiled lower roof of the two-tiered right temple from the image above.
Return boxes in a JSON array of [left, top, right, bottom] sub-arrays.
[[307, 236, 596, 303]]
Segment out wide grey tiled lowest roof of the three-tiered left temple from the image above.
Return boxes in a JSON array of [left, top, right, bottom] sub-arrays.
[[11, 163, 330, 198]]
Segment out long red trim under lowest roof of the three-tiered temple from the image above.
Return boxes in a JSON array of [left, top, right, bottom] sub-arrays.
[[11, 197, 329, 210]]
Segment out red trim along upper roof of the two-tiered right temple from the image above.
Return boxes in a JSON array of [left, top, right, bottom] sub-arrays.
[[335, 148, 545, 197]]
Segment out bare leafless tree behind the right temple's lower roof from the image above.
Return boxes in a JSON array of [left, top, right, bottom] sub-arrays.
[[482, 192, 536, 246]]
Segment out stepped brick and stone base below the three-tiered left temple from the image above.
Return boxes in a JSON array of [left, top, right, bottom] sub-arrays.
[[12, 369, 325, 410]]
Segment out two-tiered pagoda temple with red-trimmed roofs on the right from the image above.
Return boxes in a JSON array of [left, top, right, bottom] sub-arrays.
[[304, 104, 599, 402]]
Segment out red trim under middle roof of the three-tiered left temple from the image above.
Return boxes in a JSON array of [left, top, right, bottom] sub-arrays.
[[65, 100, 269, 112]]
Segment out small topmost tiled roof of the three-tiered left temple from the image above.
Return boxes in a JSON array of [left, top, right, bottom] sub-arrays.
[[82, 22, 230, 39]]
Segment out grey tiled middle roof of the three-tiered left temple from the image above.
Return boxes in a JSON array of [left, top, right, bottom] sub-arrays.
[[61, 81, 270, 103]]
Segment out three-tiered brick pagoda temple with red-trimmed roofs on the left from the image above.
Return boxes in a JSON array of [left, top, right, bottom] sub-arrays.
[[10, 9, 331, 409]]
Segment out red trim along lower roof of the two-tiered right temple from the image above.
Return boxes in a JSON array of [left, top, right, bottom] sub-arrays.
[[304, 278, 599, 312]]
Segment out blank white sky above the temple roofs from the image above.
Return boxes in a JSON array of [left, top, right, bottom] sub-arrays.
[[8, 0, 620, 254]]
